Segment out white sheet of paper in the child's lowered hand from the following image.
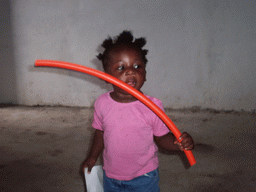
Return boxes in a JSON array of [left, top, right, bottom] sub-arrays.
[[84, 165, 104, 192]]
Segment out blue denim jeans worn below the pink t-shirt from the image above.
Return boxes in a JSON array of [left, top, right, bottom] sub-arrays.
[[103, 169, 160, 192]]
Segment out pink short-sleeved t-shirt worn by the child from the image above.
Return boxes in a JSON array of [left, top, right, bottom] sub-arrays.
[[92, 92, 169, 180]]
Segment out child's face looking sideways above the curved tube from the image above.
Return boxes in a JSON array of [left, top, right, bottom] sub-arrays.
[[106, 46, 146, 94]]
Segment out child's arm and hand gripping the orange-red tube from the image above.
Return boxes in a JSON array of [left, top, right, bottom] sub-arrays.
[[154, 132, 194, 151]]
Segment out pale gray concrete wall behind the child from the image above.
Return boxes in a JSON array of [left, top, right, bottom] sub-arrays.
[[0, 0, 256, 110]]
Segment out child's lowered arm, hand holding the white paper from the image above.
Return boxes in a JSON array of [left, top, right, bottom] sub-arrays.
[[83, 129, 104, 173]]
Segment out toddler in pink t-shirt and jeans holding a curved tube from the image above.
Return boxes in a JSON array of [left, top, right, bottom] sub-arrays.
[[83, 31, 194, 192]]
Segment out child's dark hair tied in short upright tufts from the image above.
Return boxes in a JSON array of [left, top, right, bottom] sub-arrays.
[[96, 30, 148, 71]]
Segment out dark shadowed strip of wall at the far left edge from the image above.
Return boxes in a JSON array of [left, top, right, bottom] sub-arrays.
[[0, 0, 17, 104]]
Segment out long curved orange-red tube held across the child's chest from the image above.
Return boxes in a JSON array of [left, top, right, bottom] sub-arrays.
[[35, 60, 196, 166]]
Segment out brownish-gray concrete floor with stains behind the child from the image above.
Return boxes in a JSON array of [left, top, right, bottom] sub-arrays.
[[0, 106, 256, 192]]
